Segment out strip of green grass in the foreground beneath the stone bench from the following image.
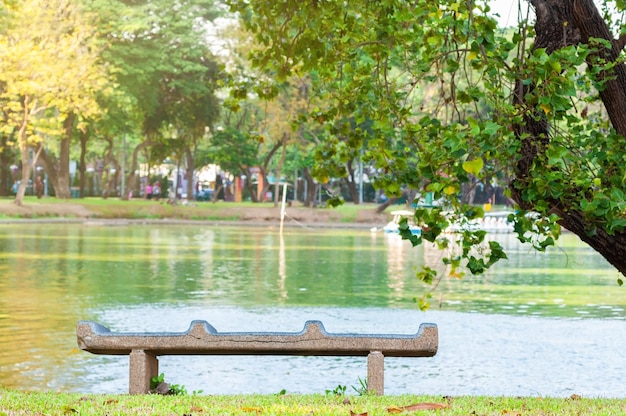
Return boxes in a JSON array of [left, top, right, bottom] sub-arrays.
[[0, 390, 626, 416]]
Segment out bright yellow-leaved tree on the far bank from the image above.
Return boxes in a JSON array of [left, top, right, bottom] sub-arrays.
[[0, 0, 107, 205]]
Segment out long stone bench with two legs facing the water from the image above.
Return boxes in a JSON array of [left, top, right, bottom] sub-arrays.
[[76, 321, 438, 395]]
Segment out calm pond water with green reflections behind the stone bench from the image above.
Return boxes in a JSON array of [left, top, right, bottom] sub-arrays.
[[0, 224, 626, 397]]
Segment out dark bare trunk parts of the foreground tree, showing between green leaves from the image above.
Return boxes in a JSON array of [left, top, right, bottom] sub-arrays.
[[511, 0, 626, 275]]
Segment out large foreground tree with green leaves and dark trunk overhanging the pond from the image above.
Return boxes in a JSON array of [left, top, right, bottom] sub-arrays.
[[229, 0, 626, 292]]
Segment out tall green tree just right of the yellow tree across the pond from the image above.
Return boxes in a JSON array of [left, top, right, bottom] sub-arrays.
[[80, 0, 222, 200]]
